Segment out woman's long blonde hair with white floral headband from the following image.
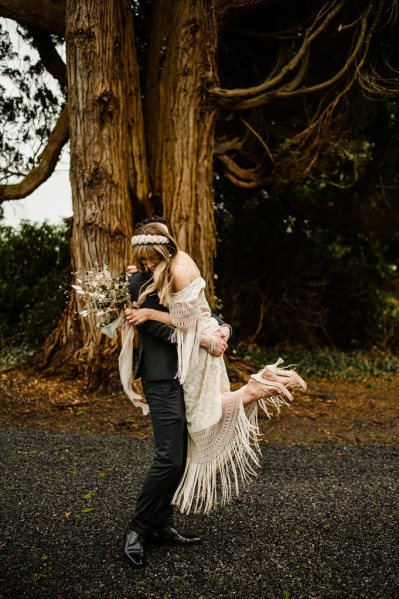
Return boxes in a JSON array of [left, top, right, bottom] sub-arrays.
[[132, 223, 179, 306]]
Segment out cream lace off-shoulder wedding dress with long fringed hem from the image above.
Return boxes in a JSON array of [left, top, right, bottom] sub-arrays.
[[169, 277, 264, 513]]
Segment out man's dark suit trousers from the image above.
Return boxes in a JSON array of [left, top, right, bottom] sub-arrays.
[[129, 379, 187, 534]]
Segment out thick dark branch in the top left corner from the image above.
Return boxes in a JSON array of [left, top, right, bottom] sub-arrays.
[[0, 0, 65, 35]]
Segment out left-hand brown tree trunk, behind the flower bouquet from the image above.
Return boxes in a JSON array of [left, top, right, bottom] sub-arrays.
[[35, 0, 148, 384]]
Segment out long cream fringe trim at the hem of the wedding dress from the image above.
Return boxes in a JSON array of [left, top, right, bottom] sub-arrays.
[[173, 389, 260, 514]]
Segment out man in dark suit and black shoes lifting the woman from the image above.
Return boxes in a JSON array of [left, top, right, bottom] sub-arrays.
[[124, 217, 230, 568]]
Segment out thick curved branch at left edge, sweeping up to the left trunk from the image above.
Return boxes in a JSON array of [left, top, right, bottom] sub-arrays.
[[0, 106, 69, 204]]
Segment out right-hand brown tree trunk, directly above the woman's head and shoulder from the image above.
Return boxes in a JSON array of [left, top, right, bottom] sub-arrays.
[[145, 0, 217, 302]]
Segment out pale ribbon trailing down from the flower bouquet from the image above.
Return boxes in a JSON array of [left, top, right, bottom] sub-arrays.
[[101, 314, 150, 416]]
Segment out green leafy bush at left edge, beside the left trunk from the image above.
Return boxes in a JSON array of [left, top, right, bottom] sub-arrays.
[[0, 222, 70, 353]]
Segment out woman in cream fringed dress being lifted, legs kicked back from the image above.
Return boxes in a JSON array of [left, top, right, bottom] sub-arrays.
[[127, 223, 306, 512]]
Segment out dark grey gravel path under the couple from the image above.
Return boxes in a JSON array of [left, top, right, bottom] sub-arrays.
[[0, 429, 399, 599]]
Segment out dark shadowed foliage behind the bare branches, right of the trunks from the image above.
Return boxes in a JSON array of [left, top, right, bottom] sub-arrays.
[[215, 0, 399, 351]]
